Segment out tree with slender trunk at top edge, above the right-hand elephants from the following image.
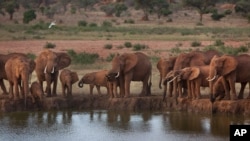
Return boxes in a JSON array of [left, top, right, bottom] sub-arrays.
[[184, 0, 216, 23]]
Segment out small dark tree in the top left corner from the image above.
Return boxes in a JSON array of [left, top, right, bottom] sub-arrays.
[[4, 0, 19, 20]]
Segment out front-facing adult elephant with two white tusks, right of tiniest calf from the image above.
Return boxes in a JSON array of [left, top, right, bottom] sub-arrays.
[[35, 49, 71, 97]]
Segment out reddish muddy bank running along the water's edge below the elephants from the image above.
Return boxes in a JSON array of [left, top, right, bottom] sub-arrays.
[[0, 95, 250, 115]]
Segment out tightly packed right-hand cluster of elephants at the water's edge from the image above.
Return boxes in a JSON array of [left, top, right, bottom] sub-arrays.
[[157, 50, 250, 102]]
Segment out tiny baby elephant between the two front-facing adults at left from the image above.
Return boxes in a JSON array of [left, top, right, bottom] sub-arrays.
[[30, 81, 43, 103]]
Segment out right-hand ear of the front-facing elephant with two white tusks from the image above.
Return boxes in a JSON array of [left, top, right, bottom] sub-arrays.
[[57, 53, 71, 70]]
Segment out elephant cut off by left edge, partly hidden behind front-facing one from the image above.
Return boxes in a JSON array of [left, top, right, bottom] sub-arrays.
[[0, 53, 26, 94]]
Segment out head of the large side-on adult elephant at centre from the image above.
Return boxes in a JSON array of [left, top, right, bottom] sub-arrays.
[[107, 53, 138, 79]]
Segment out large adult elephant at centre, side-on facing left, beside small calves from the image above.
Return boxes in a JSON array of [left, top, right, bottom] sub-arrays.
[[107, 52, 152, 97]]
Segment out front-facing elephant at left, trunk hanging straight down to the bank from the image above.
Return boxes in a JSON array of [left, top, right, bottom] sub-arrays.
[[5, 56, 36, 104]]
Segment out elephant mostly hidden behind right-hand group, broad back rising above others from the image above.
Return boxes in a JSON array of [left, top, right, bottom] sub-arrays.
[[165, 50, 220, 97]]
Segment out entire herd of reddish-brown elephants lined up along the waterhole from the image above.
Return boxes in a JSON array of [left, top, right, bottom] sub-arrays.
[[0, 49, 250, 102]]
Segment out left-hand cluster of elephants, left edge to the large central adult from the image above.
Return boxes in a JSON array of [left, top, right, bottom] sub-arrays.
[[0, 49, 152, 102]]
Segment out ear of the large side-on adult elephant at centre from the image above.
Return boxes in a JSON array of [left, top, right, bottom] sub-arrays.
[[121, 53, 138, 73]]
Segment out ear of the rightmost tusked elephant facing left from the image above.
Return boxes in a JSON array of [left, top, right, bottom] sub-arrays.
[[219, 55, 238, 75]]
